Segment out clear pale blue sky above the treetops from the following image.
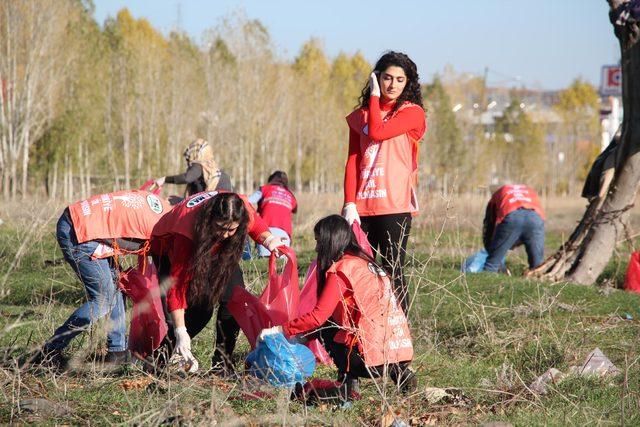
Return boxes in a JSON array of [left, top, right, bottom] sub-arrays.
[[94, 0, 619, 89]]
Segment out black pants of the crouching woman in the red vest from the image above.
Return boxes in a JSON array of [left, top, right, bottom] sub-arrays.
[[320, 323, 408, 382]]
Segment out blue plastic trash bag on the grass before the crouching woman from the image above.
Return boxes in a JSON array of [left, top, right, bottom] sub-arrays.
[[247, 333, 316, 387]]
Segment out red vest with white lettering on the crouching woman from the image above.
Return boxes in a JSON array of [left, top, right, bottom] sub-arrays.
[[327, 255, 413, 366]]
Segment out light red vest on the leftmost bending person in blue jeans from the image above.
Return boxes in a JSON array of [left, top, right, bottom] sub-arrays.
[[69, 190, 171, 247]]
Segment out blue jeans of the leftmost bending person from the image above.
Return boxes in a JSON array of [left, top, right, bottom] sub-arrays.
[[45, 214, 127, 351]]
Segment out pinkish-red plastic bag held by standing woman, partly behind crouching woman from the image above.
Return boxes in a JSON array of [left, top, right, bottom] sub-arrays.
[[298, 221, 373, 365]]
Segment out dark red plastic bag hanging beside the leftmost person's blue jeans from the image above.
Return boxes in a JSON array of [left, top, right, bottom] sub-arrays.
[[118, 257, 167, 358]]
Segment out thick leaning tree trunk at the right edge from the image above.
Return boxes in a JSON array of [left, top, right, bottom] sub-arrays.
[[529, 0, 640, 285]]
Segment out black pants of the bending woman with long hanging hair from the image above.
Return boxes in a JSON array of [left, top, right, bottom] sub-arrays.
[[153, 256, 244, 367]]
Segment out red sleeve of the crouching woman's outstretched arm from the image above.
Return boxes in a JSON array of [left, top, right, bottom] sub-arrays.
[[282, 273, 354, 336]]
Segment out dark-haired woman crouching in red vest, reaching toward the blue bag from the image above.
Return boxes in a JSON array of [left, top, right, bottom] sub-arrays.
[[262, 215, 417, 398]]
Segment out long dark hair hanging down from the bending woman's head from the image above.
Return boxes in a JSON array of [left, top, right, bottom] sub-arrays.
[[188, 193, 249, 306]]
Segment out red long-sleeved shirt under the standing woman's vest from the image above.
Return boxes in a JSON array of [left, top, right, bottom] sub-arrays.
[[344, 96, 427, 203]]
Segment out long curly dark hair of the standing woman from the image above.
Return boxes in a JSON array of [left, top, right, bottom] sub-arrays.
[[360, 51, 424, 113]]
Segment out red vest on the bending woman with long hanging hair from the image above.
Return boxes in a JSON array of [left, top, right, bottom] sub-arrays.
[[151, 191, 255, 247]]
